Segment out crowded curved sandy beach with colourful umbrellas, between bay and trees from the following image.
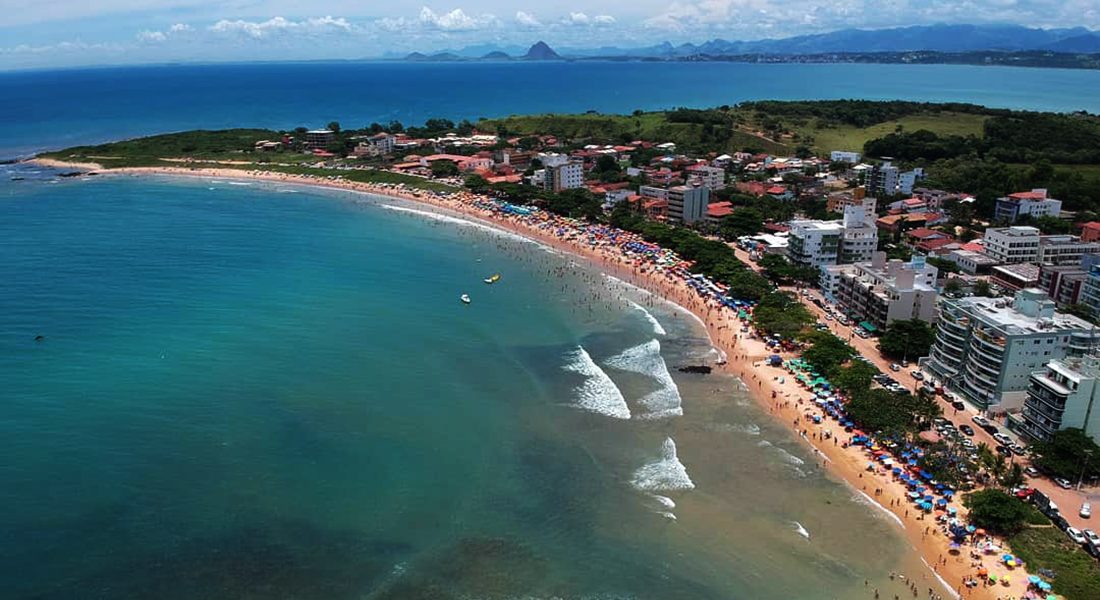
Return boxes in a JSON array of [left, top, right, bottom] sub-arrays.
[[47, 161, 1042, 599]]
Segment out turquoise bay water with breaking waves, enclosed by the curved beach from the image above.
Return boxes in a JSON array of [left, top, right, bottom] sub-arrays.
[[0, 172, 946, 599]]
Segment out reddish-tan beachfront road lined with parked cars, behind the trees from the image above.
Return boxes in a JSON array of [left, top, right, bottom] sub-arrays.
[[721, 243, 1100, 531]]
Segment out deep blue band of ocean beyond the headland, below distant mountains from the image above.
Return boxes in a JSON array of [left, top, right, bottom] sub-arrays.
[[0, 62, 1100, 159]]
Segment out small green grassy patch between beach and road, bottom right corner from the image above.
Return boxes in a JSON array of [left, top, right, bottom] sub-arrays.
[[1009, 527, 1100, 600]]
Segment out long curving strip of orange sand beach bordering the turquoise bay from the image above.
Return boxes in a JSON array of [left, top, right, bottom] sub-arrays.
[[28, 160, 1029, 600]]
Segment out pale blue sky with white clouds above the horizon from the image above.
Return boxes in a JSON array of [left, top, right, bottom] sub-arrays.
[[0, 0, 1100, 69]]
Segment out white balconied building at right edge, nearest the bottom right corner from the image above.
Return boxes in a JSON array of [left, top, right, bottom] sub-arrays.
[[1009, 356, 1100, 444]]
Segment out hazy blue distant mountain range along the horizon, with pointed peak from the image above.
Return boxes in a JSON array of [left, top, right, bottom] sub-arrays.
[[400, 24, 1100, 61]]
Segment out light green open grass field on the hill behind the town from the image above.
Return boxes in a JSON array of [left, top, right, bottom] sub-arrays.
[[792, 112, 988, 153]]
